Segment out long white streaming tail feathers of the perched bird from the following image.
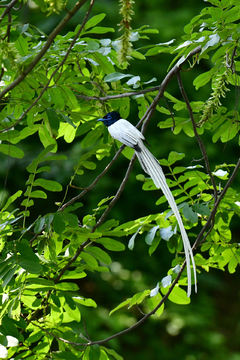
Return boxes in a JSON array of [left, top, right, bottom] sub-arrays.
[[136, 139, 197, 296]]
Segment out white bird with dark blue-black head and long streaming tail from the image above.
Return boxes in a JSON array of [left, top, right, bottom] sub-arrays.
[[98, 111, 197, 296]]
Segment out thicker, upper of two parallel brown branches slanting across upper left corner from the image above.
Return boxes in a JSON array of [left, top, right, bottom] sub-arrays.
[[0, 0, 87, 99]]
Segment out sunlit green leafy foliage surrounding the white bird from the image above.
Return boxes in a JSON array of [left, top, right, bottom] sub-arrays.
[[0, 0, 240, 360]]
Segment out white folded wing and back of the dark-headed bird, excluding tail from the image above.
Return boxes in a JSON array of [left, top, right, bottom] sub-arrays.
[[108, 119, 145, 149]]
